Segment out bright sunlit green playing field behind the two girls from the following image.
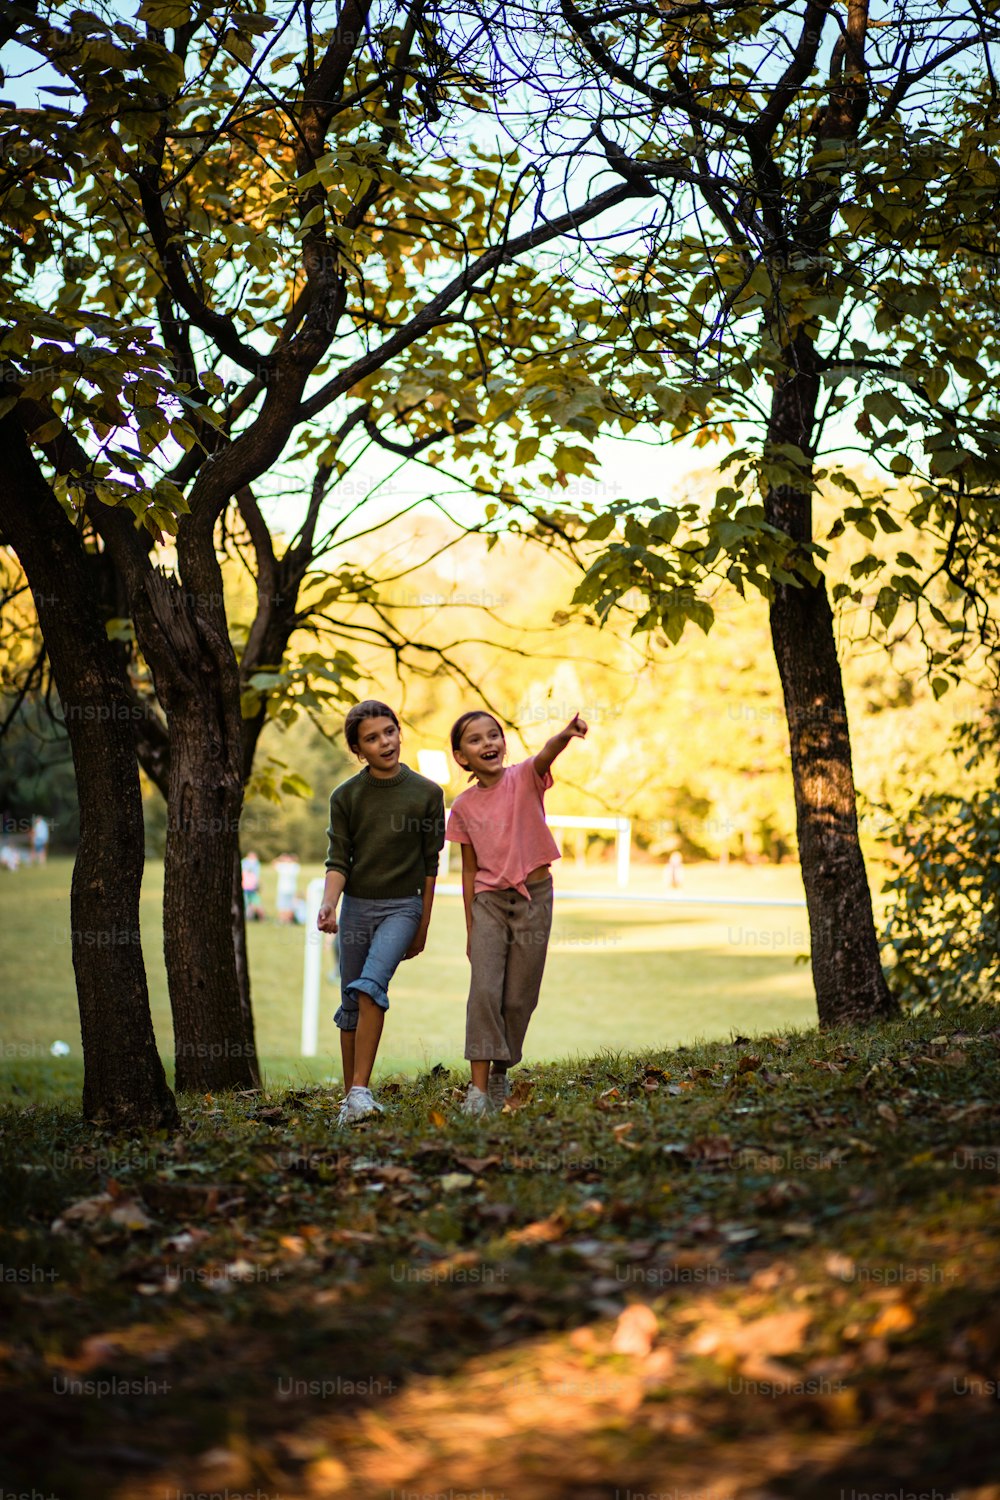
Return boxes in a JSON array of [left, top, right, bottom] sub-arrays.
[[0, 858, 816, 1097]]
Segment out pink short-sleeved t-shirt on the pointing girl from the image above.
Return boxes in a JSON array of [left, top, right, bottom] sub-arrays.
[[447, 756, 559, 900]]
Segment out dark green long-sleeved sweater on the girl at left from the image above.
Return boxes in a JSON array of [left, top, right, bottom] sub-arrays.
[[327, 765, 444, 902]]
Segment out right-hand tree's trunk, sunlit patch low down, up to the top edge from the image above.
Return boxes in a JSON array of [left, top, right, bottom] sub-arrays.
[[765, 0, 898, 1026]]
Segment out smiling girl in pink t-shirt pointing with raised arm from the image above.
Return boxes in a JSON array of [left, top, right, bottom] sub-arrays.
[[447, 710, 586, 1115]]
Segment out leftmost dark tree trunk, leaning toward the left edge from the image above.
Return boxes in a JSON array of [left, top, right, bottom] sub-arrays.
[[0, 413, 180, 1130]]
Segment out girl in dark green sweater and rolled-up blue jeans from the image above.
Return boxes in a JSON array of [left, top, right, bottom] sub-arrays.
[[316, 699, 444, 1125]]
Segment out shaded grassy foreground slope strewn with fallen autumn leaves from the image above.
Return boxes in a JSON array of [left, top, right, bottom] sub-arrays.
[[0, 1002, 1000, 1500]]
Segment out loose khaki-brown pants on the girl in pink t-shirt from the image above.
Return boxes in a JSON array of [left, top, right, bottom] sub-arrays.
[[465, 876, 552, 1067]]
